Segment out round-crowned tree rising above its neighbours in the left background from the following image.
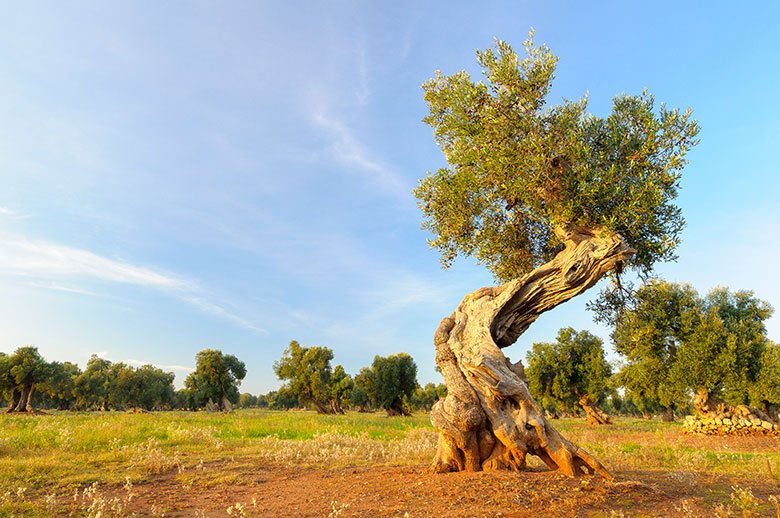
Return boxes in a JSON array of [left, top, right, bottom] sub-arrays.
[[184, 349, 246, 407]]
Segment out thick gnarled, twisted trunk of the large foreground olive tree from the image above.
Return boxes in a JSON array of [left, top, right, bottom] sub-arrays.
[[431, 226, 634, 478]]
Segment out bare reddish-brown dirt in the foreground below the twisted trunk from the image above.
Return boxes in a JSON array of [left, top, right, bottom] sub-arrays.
[[114, 465, 780, 518]]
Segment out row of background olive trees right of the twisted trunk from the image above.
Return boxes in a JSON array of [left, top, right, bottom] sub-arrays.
[[525, 280, 780, 423]]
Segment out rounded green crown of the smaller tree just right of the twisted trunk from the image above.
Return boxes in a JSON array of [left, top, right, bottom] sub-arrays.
[[525, 327, 612, 412]]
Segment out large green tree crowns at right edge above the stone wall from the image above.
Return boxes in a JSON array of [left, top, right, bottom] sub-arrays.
[[612, 281, 780, 408]]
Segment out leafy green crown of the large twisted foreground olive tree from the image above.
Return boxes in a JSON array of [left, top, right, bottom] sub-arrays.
[[415, 33, 698, 281]]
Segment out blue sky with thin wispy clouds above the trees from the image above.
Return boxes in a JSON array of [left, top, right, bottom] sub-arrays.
[[0, 1, 780, 394]]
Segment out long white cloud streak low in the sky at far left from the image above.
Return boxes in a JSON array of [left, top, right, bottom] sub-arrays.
[[0, 236, 265, 333]]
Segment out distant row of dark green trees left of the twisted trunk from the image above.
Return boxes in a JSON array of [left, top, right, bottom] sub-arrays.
[[0, 341, 446, 415]]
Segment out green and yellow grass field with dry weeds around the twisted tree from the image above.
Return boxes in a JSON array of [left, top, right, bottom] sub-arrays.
[[0, 410, 780, 517]]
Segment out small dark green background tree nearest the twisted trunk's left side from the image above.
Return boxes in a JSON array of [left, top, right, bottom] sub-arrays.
[[370, 353, 417, 416]]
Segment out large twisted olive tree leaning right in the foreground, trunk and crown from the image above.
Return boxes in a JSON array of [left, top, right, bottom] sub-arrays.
[[415, 33, 698, 477]]
